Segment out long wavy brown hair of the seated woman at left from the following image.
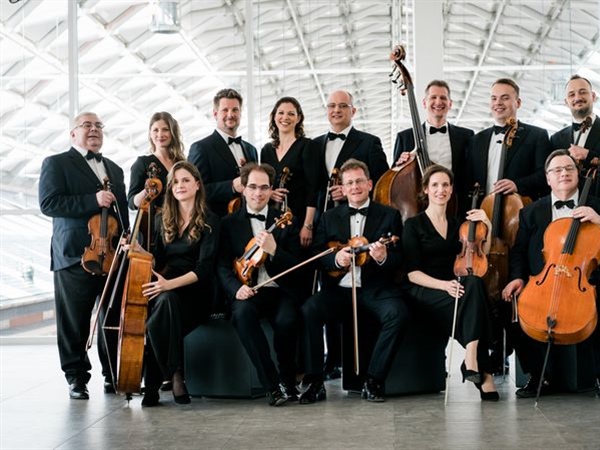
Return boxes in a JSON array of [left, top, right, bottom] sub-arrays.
[[162, 161, 210, 244]]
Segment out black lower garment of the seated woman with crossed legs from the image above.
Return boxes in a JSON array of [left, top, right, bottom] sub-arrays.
[[408, 276, 491, 373]]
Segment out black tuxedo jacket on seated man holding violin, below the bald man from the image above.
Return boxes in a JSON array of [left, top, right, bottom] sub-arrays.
[[313, 201, 402, 291]]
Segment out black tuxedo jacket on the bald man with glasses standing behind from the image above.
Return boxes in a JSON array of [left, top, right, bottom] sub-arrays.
[[313, 127, 390, 192]]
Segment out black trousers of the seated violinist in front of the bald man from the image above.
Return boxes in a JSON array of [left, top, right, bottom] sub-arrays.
[[302, 287, 409, 380]]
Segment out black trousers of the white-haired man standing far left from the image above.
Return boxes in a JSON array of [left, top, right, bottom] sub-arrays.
[[54, 264, 111, 383]]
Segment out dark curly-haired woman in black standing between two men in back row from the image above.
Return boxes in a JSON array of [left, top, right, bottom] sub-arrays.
[[260, 97, 319, 247]]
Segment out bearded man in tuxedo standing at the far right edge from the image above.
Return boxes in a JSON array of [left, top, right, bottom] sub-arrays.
[[550, 75, 600, 197]]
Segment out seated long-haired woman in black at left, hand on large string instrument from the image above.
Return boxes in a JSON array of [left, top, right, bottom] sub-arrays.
[[142, 161, 220, 406]]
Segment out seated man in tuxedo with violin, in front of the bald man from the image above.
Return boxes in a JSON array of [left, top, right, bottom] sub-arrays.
[[300, 159, 408, 404]]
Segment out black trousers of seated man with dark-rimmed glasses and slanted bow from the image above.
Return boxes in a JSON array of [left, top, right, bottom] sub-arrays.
[[231, 287, 298, 390]]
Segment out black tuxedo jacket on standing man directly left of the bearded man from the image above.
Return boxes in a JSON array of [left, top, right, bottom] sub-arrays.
[[465, 122, 552, 200]]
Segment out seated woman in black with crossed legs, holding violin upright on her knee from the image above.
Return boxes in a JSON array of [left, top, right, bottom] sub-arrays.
[[402, 165, 499, 400]]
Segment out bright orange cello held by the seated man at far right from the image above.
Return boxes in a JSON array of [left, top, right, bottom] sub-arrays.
[[518, 170, 600, 345]]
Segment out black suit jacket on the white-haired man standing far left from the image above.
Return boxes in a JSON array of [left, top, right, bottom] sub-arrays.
[[39, 147, 129, 271]]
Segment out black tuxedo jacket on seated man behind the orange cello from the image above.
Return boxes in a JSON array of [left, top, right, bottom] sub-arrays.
[[509, 195, 600, 282]]
